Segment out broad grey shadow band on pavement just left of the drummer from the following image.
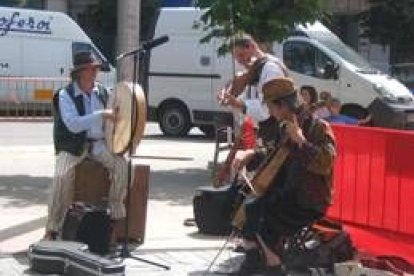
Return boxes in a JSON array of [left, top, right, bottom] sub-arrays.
[[0, 175, 52, 207]]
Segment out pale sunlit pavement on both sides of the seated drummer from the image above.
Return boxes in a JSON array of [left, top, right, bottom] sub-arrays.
[[0, 124, 246, 276]]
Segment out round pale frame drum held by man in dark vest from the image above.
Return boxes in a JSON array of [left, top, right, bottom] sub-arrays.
[[105, 81, 147, 155]]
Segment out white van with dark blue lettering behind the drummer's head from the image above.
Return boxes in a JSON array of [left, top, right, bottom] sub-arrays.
[[0, 7, 116, 112]]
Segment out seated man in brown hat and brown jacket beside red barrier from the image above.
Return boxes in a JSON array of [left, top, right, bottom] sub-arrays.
[[234, 77, 335, 275]]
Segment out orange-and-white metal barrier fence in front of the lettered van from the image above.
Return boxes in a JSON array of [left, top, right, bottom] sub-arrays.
[[0, 77, 69, 119]]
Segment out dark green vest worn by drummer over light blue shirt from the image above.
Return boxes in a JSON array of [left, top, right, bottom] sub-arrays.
[[52, 83, 108, 156]]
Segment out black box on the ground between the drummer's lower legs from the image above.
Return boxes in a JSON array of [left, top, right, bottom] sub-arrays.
[[62, 202, 112, 255]]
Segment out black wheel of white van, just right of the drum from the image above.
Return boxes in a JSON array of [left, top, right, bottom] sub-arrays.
[[159, 104, 191, 137]]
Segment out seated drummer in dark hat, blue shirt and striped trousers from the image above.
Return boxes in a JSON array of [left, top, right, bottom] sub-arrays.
[[44, 52, 128, 239]]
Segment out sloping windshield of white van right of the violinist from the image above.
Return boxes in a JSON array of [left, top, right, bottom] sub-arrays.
[[309, 32, 379, 74]]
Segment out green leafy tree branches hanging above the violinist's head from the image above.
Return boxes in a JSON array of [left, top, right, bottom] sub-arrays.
[[196, 0, 326, 53]]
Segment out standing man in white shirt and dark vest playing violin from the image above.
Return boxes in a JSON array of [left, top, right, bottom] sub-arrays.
[[217, 34, 287, 181]]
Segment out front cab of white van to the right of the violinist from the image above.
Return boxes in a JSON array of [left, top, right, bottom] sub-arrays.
[[280, 22, 414, 129]]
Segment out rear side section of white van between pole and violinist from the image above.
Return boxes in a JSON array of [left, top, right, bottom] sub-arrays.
[[148, 8, 233, 136]]
